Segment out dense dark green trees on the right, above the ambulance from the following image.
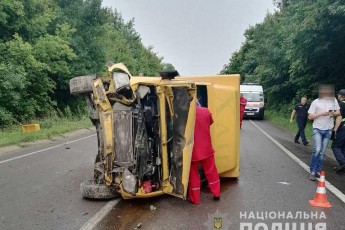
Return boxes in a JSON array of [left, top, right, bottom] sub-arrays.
[[222, 0, 345, 110]]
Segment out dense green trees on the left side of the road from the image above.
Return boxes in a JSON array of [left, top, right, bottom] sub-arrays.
[[0, 0, 163, 127]]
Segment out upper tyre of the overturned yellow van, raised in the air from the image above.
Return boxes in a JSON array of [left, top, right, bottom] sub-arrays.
[[69, 76, 96, 95]]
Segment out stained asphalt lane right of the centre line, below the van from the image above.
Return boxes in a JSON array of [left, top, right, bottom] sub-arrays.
[[96, 121, 345, 230]]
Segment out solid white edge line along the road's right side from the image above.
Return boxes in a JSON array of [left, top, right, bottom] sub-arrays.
[[250, 120, 345, 203]]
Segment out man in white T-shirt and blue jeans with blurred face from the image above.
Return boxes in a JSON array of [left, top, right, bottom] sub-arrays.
[[308, 85, 340, 181]]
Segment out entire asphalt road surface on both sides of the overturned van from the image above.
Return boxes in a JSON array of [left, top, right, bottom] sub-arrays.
[[0, 121, 345, 230]]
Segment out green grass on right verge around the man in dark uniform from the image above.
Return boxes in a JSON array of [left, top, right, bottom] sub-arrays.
[[265, 110, 313, 142]]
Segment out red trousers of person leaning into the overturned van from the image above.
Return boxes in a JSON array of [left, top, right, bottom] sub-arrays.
[[188, 156, 220, 204]]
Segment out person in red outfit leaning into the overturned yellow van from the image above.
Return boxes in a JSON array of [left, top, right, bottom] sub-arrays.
[[188, 106, 220, 204]]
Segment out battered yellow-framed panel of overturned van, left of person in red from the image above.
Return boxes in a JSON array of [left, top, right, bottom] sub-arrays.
[[159, 84, 196, 199]]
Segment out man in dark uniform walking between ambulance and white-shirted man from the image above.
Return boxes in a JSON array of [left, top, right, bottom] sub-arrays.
[[290, 96, 309, 145]]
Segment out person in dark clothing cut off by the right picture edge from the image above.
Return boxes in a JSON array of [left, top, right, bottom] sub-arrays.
[[332, 89, 345, 174]]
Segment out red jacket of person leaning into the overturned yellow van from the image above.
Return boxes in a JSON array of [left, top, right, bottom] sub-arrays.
[[192, 106, 214, 161]]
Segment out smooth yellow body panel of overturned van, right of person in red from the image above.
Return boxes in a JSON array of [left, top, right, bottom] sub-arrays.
[[181, 74, 240, 178]]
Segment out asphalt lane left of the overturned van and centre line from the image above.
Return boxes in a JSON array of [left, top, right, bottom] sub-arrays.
[[0, 131, 106, 230]]
